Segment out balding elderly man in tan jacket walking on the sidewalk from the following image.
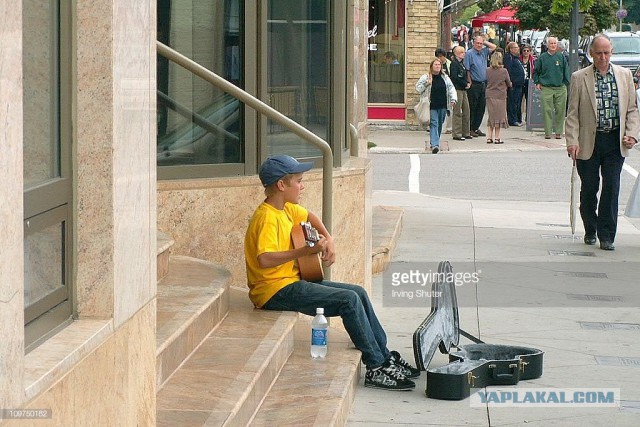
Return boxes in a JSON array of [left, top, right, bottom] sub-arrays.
[[566, 34, 640, 251]]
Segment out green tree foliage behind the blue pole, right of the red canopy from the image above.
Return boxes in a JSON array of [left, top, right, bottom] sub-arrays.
[[512, 0, 618, 38]]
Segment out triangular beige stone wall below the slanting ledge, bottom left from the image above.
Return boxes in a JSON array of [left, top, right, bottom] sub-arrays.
[[0, 303, 156, 427]]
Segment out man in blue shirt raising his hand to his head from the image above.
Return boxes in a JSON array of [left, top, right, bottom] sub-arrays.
[[464, 35, 496, 136]]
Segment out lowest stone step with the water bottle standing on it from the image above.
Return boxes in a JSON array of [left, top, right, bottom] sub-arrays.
[[251, 316, 361, 427]]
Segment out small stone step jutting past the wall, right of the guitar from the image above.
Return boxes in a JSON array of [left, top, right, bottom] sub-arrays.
[[371, 206, 404, 275]]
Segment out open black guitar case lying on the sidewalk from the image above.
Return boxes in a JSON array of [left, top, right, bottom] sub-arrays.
[[413, 261, 543, 400]]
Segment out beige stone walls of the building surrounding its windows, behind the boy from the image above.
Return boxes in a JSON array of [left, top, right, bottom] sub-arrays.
[[0, 0, 372, 426]]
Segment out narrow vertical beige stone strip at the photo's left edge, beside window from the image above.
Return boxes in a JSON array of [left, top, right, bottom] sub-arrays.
[[0, 0, 24, 408]]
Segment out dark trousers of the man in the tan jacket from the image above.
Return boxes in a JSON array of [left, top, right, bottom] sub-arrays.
[[576, 131, 624, 242]]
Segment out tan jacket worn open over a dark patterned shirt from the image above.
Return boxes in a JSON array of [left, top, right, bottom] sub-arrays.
[[565, 64, 640, 160]]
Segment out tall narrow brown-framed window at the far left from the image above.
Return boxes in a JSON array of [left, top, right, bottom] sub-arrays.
[[22, 0, 71, 350]]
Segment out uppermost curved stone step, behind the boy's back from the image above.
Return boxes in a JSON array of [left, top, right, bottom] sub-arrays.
[[156, 256, 230, 389]]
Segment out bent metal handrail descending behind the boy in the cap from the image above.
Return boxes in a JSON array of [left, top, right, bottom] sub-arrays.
[[156, 40, 333, 233]]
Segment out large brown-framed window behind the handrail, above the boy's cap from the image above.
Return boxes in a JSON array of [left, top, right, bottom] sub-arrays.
[[157, 0, 348, 179]]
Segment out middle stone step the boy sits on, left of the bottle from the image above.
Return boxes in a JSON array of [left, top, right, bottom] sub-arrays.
[[157, 288, 298, 427]]
